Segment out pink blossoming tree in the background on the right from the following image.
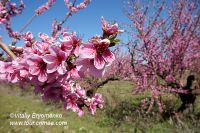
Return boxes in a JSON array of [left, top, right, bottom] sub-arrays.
[[126, 0, 200, 112]]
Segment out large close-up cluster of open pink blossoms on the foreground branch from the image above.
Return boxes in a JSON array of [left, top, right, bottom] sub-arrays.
[[0, 17, 122, 116]]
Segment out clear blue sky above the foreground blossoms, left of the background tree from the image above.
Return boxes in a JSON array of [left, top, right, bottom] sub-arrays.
[[0, 0, 128, 45]]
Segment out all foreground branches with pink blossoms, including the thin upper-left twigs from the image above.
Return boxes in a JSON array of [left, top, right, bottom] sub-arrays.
[[0, 0, 121, 116]]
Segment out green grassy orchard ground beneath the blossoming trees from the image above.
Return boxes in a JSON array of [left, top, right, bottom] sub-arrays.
[[0, 81, 200, 133]]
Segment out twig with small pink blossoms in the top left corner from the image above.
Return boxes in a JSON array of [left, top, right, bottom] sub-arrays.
[[0, 0, 25, 38]]
